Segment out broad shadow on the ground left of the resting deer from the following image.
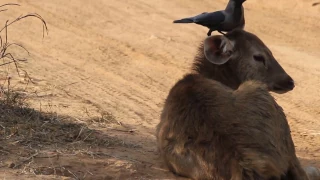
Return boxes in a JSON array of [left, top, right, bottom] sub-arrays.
[[0, 103, 180, 179]]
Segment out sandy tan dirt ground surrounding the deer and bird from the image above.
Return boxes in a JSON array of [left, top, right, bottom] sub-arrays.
[[0, 0, 320, 180]]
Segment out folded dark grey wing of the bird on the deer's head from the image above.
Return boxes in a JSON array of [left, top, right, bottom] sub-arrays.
[[192, 11, 225, 27]]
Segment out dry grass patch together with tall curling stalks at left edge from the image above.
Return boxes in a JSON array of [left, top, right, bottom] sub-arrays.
[[0, 4, 137, 179]]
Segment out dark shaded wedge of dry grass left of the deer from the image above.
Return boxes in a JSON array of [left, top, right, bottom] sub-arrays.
[[0, 102, 124, 149]]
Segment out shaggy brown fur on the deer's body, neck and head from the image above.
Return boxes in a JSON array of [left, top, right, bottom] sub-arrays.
[[156, 30, 307, 180]]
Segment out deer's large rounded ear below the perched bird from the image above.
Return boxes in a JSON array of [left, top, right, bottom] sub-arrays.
[[203, 35, 234, 65]]
